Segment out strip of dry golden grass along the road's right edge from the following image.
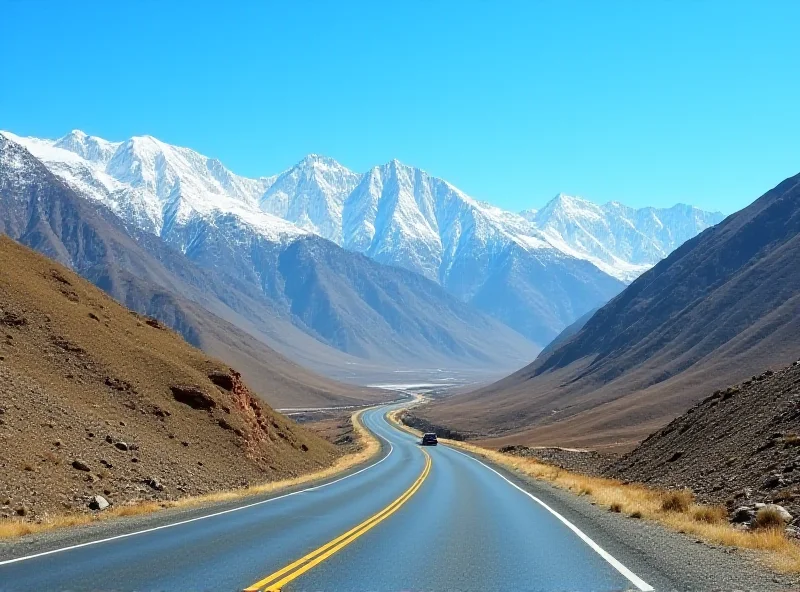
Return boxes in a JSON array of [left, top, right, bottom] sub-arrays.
[[388, 410, 800, 573]]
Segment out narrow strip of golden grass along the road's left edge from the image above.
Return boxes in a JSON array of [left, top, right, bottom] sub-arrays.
[[0, 409, 380, 539]]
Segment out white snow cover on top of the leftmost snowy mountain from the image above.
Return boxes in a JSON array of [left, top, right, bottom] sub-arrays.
[[3, 130, 296, 243]]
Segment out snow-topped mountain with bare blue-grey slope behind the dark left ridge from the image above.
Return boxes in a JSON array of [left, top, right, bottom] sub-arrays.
[[6, 133, 537, 379]]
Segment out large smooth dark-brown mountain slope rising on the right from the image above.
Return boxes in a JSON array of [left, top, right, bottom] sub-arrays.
[[420, 170, 800, 447]]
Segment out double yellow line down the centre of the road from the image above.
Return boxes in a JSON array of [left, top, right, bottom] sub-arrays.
[[244, 450, 431, 592]]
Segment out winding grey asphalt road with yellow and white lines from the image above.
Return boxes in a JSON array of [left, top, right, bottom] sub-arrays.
[[0, 408, 651, 592]]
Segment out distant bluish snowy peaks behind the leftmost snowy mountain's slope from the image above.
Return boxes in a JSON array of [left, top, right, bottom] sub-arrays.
[[247, 155, 722, 345]]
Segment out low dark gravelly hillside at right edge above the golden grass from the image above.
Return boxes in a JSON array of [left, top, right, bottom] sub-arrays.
[[605, 362, 800, 516]]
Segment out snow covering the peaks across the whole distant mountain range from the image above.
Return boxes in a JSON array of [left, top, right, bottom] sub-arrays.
[[3, 130, 722, 291]]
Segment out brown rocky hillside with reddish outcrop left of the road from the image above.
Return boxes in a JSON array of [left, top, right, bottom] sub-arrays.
[[0, 237, 337, 517]]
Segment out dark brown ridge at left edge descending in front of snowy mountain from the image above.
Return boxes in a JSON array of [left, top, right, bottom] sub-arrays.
[[0, 135, 388, 407]]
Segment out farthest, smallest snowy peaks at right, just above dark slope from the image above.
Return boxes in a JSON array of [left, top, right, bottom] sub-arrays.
[[522, 193, 724, 281]]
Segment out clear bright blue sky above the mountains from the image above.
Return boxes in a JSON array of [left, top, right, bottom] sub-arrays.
[[0, 0, 800, 213]]
